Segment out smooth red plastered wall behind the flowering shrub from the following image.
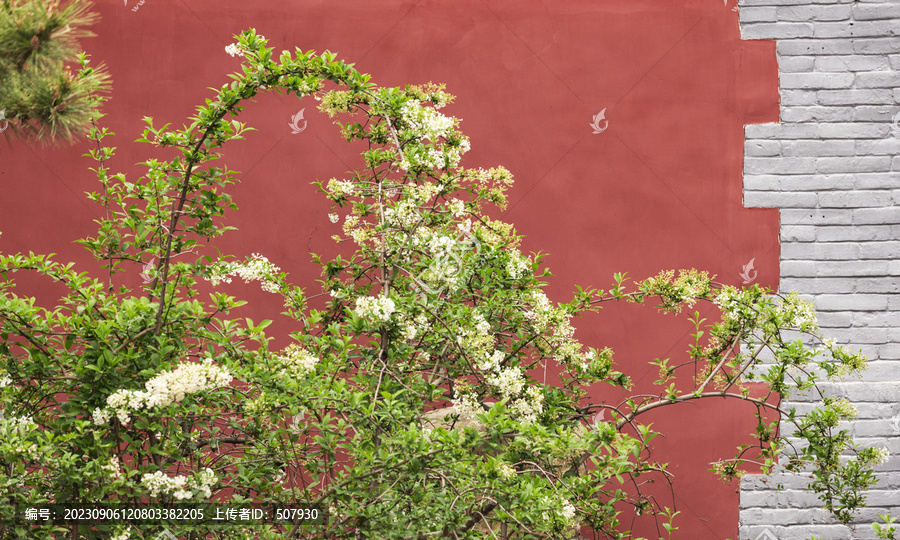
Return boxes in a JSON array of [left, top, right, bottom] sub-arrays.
[[0, 0, 779, 540]]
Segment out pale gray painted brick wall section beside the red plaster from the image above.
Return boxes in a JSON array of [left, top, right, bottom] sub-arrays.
[[739, 0, 900, 540]]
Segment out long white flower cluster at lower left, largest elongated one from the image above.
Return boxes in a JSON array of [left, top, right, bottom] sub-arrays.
[[93, 358, 232, 425]]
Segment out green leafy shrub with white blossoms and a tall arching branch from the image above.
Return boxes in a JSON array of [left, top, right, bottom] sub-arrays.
[[0, 31, 883, 539]]
